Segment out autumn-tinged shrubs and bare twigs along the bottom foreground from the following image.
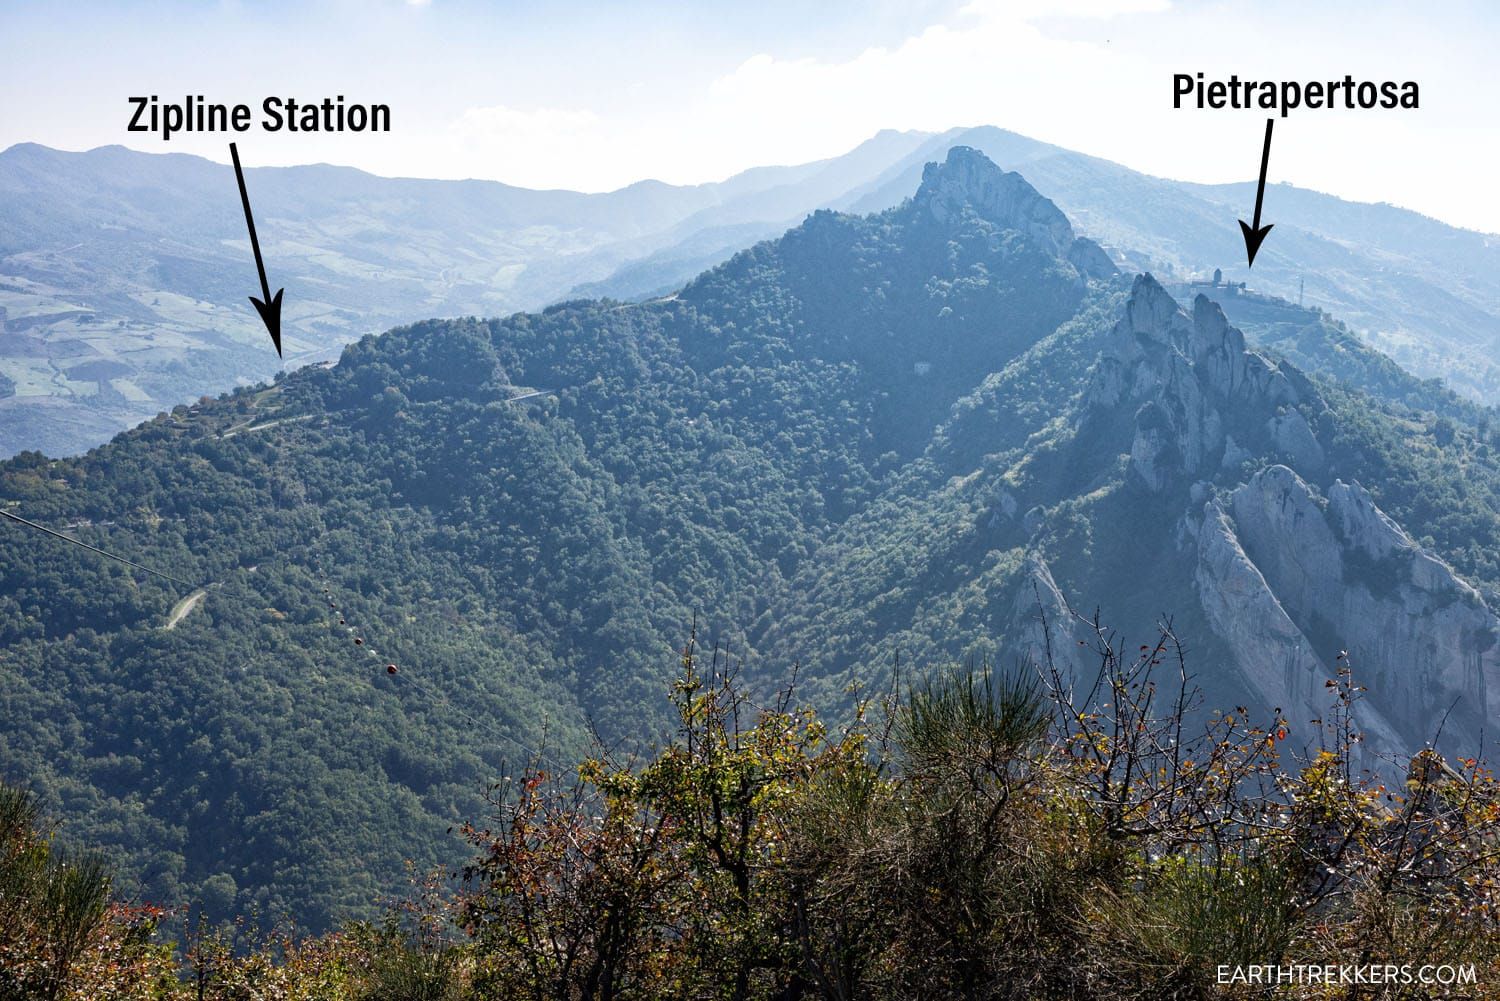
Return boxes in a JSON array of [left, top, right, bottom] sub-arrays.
[[0, 629, 1500, 1001]]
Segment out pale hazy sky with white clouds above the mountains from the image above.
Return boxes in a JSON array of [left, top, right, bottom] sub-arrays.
[[0, 0, 1500, 233]]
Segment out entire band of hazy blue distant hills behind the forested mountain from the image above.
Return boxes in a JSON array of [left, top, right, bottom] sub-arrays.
[[0, 128, 1500, 455]]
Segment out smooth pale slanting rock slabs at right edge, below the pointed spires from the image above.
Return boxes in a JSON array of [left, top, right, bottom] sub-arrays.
[[1197, 465, 1500, 753]]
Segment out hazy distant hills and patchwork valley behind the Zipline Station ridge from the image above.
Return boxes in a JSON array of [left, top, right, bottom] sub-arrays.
[[0, 132, 926, 456]]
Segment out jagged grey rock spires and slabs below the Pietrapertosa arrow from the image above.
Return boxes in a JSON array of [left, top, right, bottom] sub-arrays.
[[1016, 275, 1500, 764]]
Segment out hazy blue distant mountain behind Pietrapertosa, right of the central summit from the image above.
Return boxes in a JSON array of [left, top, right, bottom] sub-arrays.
[[590, 126, 1500, 404]]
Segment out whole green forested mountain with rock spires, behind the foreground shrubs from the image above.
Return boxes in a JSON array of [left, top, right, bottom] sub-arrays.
[[0, 147, 1500, 926]]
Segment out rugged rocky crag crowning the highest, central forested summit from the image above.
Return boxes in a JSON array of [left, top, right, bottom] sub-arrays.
[[914, 146, 1115, 278]]
